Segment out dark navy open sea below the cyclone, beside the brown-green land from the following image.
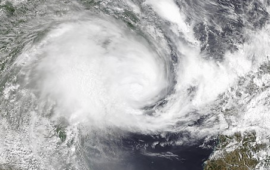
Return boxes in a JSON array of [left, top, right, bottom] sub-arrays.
[[89, 134, 215, 170]]
